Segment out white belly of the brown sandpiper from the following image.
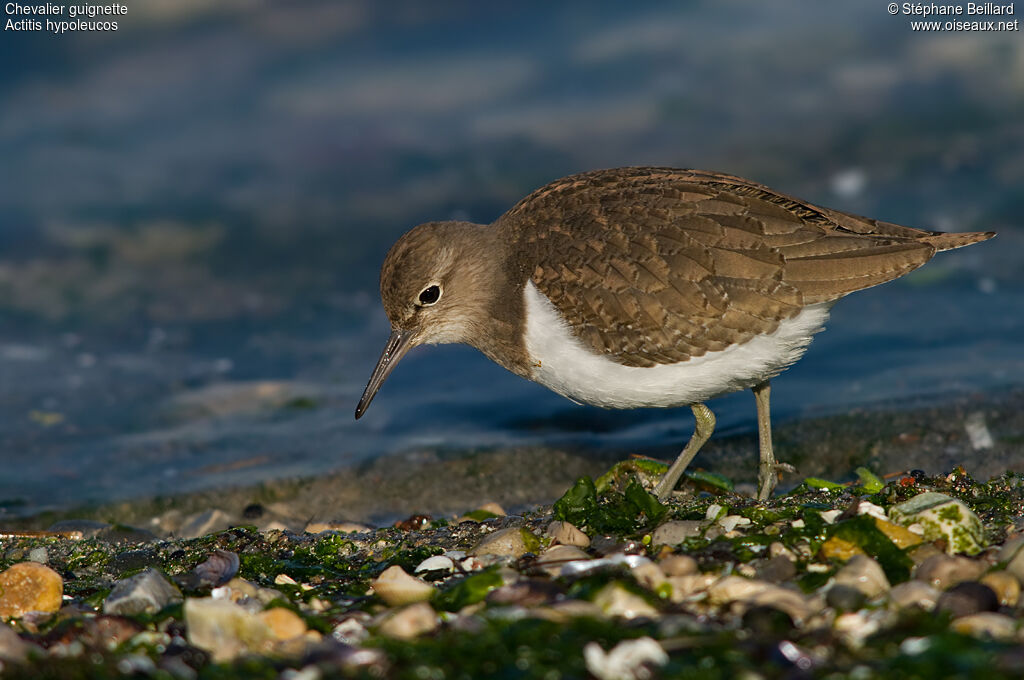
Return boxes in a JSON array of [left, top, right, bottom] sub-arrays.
[[523, 282, 831, 409]]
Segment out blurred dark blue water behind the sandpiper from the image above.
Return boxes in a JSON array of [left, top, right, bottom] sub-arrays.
[[0, 0, 1024, 513]]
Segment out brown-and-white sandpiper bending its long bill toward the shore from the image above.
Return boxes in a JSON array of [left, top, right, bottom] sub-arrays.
[[355, 167, 995, 501]]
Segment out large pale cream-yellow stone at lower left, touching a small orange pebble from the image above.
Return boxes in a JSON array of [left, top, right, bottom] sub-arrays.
[[184, 597, 273, 663]]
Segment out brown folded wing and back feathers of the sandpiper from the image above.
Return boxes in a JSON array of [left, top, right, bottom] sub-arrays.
[[496, 168, 936, 367]]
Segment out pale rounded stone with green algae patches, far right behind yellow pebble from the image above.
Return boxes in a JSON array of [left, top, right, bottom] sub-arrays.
[[889, 492, 987, 555]]
